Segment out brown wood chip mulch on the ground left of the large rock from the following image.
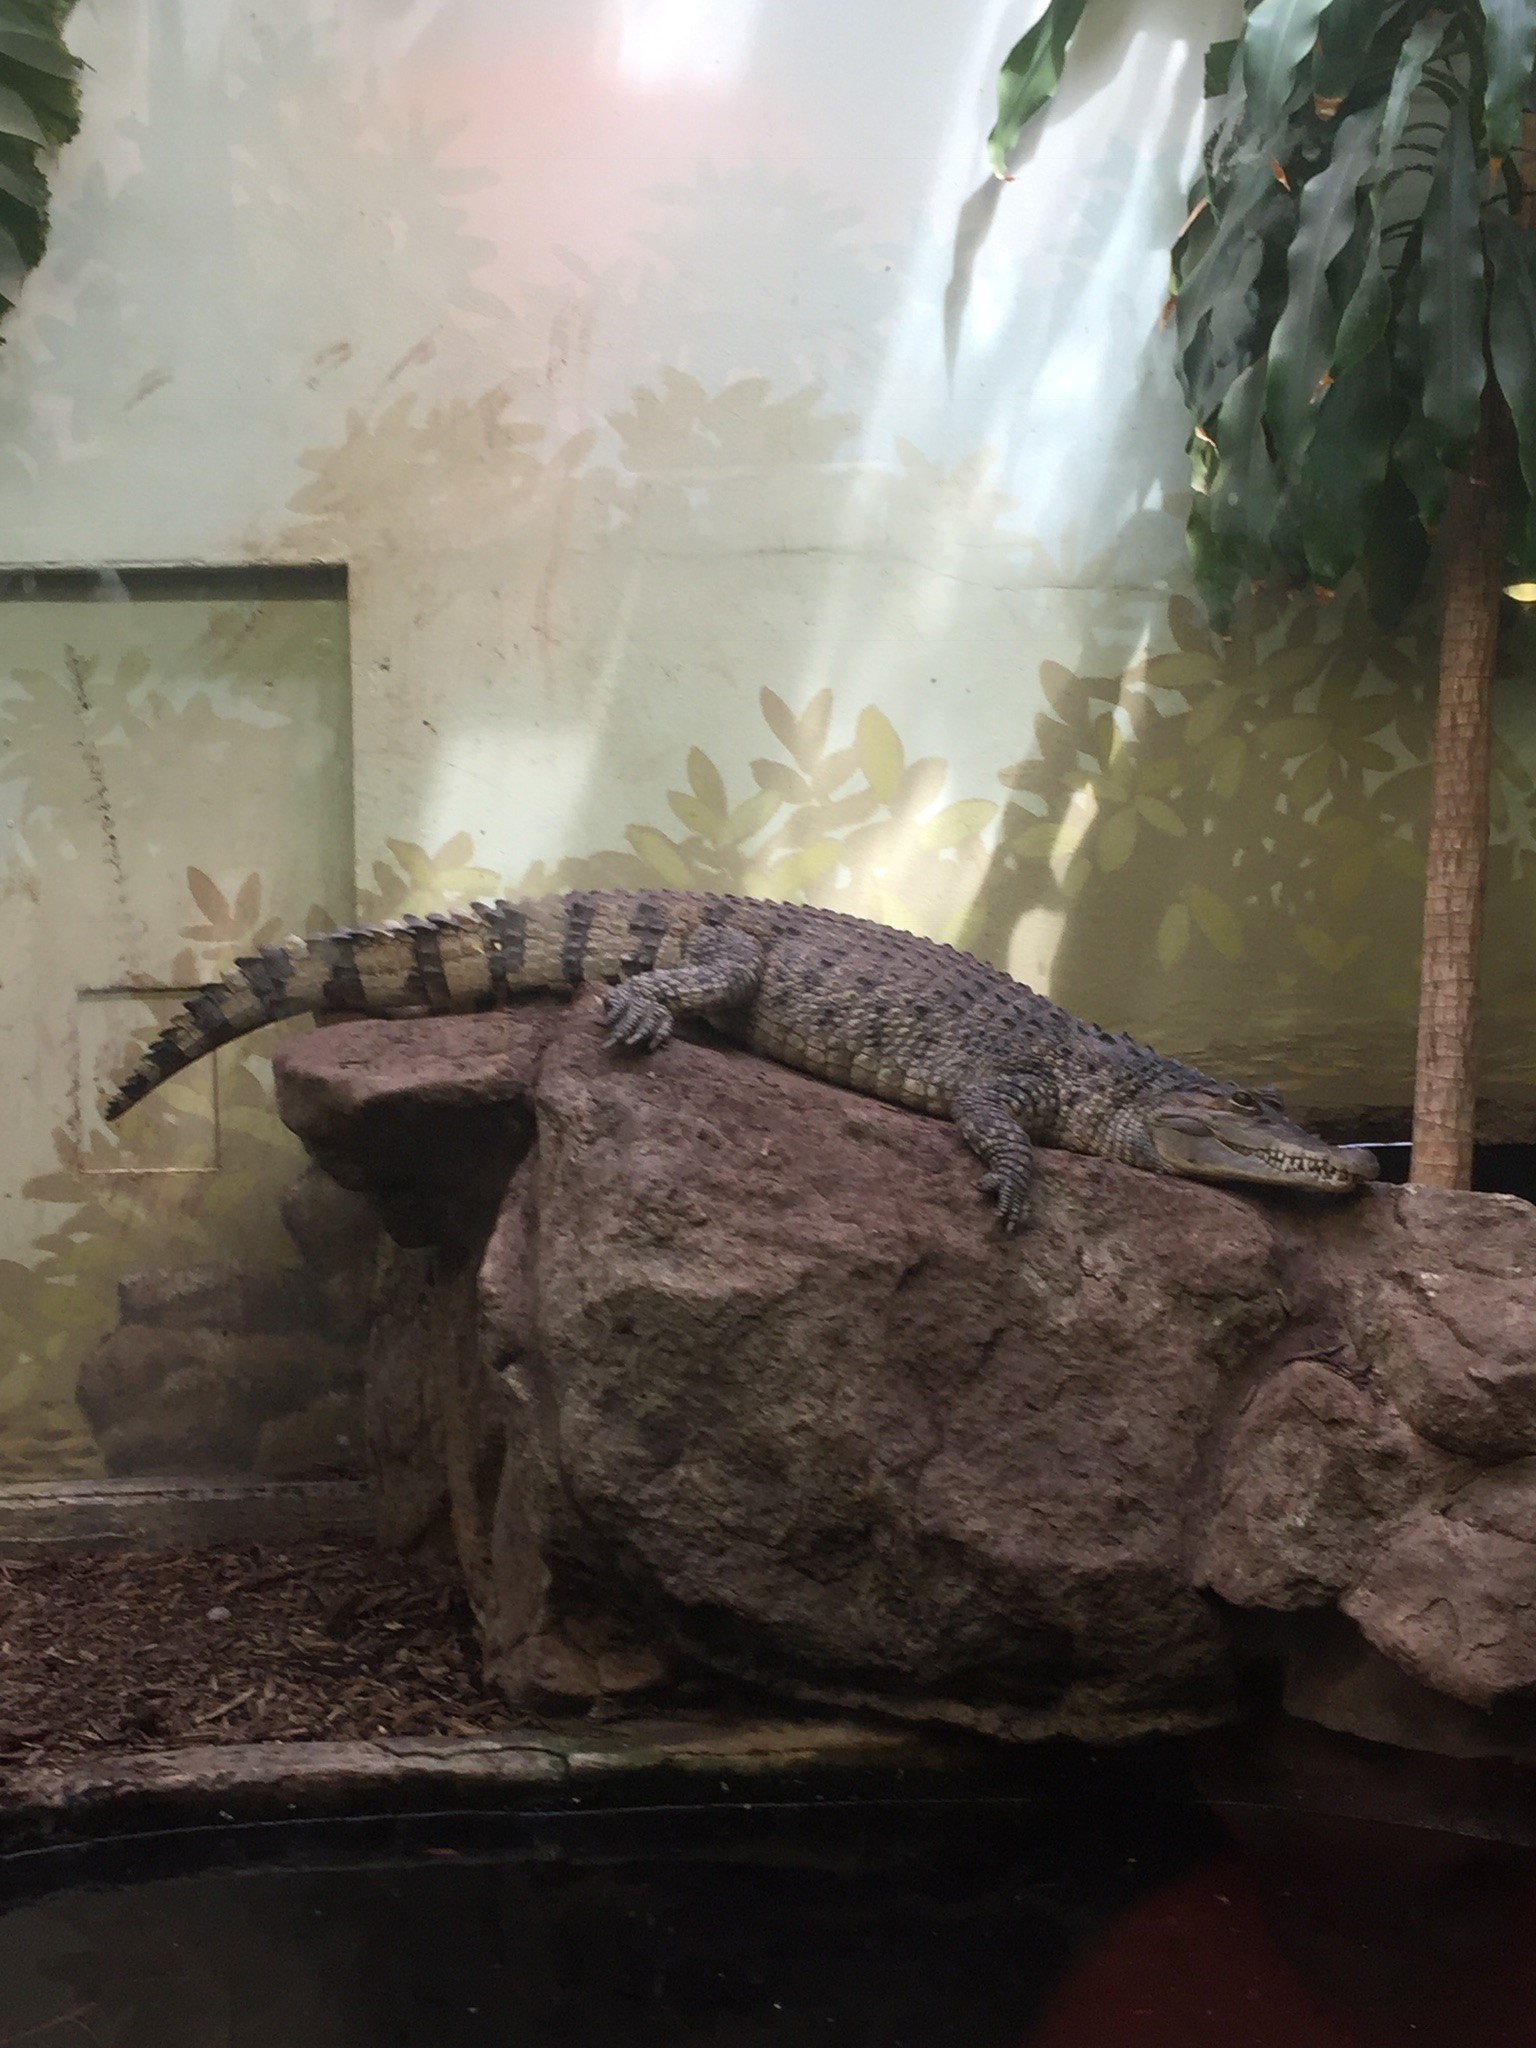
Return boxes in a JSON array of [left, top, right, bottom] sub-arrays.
[[0, 1540, 526, 1767]]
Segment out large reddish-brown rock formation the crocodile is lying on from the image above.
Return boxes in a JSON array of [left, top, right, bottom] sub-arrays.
[[279, 997, 1536, 1749]]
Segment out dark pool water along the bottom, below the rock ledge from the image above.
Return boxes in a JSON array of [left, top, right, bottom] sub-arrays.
[[0, 1757, 1536, 2048]]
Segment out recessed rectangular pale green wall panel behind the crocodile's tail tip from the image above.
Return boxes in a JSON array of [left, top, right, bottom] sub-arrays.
[[0, 569, 352, 1481]]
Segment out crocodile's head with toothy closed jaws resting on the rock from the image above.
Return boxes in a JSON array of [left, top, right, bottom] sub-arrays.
[[1143, 1085, 1380, 1194]]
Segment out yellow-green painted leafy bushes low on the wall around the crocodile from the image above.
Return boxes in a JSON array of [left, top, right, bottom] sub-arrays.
[[0, 596, 1536, 1477]]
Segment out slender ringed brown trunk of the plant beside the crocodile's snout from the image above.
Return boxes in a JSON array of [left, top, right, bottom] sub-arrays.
[[1411, 393, 1505, 1188]]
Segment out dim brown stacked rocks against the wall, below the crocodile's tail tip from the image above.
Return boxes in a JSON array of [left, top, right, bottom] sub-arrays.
[[76, 1167, 379, 1479]]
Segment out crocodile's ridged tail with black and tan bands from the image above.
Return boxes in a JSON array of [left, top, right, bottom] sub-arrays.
[[102, 891, 708, 1122]]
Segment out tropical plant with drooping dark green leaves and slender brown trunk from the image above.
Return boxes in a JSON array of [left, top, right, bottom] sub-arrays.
[[989, 0, 1536, 1188]]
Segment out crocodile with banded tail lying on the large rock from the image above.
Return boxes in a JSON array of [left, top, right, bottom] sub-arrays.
[[104, 889, 1376, 1231]]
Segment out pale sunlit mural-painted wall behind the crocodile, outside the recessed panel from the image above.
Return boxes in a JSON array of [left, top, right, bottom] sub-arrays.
[[0, 0, 1536, 1474]]
